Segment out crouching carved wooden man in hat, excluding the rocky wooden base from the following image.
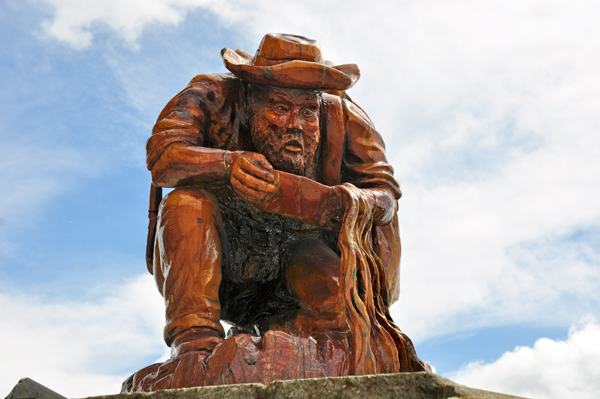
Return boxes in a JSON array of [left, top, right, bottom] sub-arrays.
[[147, 34, 426, 382]]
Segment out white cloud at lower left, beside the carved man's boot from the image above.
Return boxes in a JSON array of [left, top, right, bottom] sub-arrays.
[[0, 275, 168, 398]]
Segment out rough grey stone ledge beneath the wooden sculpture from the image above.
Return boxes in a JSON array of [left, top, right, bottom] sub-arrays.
[[90, 372, 518, 399]]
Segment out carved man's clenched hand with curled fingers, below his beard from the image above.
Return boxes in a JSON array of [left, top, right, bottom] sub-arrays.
[[229, 151, 279, 204]]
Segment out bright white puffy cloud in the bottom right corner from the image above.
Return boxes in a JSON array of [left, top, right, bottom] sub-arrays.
[[450, 319, 600, 399]]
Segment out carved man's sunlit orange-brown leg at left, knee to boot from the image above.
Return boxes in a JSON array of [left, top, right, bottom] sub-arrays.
[[154, 187, 224, 357]]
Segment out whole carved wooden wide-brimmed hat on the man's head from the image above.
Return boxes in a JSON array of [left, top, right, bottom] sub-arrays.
[[221, 33, 360, 90]]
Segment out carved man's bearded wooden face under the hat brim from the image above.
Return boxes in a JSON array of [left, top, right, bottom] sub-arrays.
[[250, 87, 320, 176]]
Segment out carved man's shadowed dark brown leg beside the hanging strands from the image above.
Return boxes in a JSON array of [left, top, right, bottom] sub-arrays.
[[285, 239, 348, 336]]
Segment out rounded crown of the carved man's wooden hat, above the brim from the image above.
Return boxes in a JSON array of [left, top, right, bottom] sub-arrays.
[[252, 33, 323, 66]]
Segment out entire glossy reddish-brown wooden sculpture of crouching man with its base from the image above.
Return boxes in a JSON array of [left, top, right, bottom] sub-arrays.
[[123, 34, 429, 392]]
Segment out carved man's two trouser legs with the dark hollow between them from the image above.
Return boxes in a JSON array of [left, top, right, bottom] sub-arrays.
[[153, 187, 347, 346]]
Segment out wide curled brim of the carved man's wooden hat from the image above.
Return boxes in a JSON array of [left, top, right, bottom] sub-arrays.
[[221, 48, 360, 90]]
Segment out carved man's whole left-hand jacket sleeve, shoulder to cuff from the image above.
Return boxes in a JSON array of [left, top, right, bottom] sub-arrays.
[[146, 75, 238, 187]]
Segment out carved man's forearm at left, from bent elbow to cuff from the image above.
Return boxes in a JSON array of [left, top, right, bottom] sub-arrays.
[[150, 143, 231, 187]]
